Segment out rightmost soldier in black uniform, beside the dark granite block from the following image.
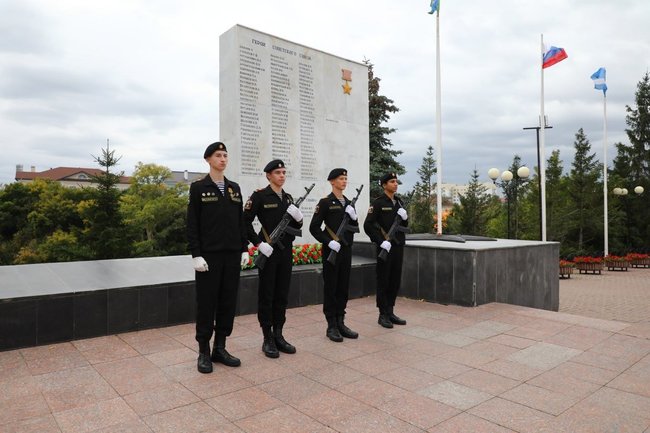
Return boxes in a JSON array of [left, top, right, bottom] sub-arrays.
[[363, 173, 408, 328]]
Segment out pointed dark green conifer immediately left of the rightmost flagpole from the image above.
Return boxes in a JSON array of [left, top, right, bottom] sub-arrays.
[[568, 128, 603, 254]]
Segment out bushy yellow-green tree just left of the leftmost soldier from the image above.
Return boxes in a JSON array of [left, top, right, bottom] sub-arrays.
[[120, 162, 187, 256]]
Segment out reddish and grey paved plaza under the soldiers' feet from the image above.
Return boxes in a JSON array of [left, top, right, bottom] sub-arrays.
[[0, 269, 650, 433]]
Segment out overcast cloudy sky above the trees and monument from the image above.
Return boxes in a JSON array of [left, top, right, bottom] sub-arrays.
[[0, 0, 650, 188]]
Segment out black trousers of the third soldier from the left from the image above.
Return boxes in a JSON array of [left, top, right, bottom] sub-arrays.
[[323, 245, 352, 318]]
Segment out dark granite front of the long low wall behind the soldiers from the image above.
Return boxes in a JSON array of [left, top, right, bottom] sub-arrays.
[[0, 258, 375, 350]]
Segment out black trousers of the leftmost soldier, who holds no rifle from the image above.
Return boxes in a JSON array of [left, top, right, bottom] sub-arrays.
[[195, 251, 241, 342]]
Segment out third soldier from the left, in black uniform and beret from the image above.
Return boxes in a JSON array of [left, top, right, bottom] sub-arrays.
[[309, 168, 359, 342]]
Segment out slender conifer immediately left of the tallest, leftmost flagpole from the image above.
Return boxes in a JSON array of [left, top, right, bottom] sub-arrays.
[[408, 146, 438, 233]]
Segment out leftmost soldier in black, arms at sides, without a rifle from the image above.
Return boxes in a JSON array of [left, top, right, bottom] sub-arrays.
[[187, 142, 248, 373]]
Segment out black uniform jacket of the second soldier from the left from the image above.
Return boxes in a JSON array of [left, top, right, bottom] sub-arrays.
[[244, 185, 302, 245]]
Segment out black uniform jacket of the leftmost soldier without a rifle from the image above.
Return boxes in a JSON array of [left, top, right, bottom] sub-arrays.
[[187, 175, 248, 257]]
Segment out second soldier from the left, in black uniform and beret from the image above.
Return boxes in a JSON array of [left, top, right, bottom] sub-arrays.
[[244, 159, 303, 358]]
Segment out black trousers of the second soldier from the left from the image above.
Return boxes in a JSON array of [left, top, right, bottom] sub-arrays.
[[257, 244, 293, 326]]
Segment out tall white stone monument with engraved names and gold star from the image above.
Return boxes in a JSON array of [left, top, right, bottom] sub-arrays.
[[219, 25, 370, 243]]
